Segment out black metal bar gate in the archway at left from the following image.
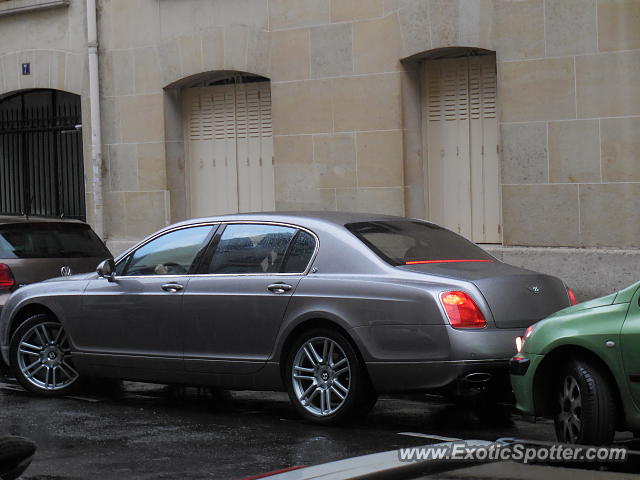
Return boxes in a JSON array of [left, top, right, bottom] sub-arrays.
[[0, 90, 86, 220]]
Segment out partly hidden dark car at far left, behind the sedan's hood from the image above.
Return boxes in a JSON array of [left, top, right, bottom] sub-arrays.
[[0, 216, 112, 318]]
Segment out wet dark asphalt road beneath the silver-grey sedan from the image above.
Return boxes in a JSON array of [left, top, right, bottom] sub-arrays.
[[0, 378, 636, 480]]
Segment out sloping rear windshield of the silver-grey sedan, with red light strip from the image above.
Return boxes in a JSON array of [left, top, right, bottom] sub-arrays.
[[345, 220, 493, 265]]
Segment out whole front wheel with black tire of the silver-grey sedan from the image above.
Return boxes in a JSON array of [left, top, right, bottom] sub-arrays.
[[9, 313, 79, 397]]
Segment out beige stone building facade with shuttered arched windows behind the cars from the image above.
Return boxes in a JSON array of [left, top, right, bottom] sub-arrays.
[[0, 0, 640, 298]]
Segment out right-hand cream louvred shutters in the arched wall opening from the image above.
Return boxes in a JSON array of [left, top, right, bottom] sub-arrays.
[[422, 55, 501, 243]]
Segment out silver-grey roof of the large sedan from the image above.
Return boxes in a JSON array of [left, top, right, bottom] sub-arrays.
[[171, 211, 420, 231]]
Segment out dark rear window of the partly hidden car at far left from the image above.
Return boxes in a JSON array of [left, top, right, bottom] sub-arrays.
[[0, 222, 111, 259]]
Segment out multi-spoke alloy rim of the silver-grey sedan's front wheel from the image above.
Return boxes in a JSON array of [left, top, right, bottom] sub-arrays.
[[17, 322, 78, 390]]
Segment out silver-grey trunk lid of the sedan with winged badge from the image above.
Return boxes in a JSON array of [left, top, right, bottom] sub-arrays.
[[399, 260, 571, 328]]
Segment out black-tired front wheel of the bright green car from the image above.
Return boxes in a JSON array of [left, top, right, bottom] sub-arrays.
[[553, 360, 617, 445]]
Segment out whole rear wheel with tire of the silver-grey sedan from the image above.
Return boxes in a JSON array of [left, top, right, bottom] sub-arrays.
[[285, 329, 377, 424]]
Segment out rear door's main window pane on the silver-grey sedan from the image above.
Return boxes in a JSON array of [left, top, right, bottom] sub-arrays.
[[208, 224, 296, 274]]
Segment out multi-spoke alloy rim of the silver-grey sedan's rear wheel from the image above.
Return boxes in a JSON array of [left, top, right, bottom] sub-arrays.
[[291, 337, 351, 416]]
